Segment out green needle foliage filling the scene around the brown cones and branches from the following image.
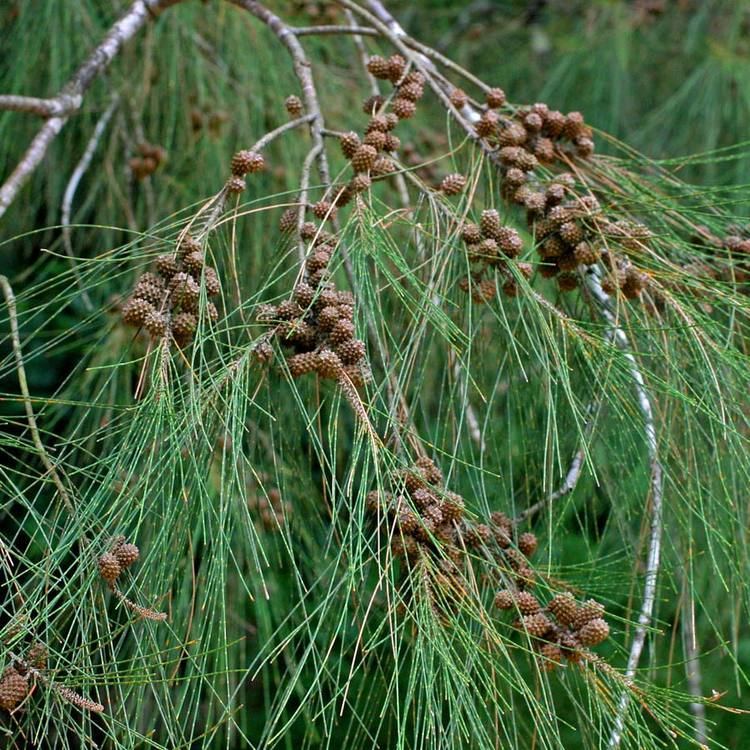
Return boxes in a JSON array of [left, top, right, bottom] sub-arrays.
[[0, 0, 750, 748]]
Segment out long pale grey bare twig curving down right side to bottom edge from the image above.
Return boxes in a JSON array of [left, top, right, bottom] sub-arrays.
[[584, 266, 663, 750]]
